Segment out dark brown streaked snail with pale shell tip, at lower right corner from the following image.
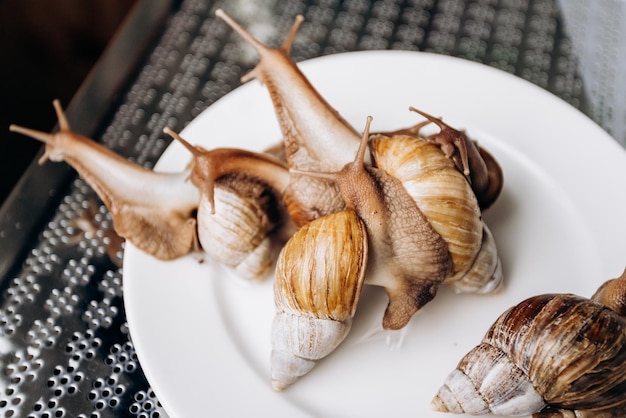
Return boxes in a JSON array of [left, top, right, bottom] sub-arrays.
[[432, 270, 626, 418]]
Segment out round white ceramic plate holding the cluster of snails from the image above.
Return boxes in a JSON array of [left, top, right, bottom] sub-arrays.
[[124, 51, 626, 418]]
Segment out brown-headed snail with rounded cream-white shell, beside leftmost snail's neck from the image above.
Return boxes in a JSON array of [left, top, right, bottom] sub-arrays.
[[165, 128, 295, 279]]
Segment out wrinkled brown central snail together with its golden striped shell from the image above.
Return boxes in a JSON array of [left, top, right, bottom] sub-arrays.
[[291, 117, 502, 329]]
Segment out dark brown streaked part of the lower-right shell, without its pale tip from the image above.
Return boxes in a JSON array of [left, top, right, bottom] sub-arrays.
[[483, 294, 626, 409]]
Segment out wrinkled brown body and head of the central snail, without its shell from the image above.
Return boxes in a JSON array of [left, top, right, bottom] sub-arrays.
[[292, 117, 453, 329]]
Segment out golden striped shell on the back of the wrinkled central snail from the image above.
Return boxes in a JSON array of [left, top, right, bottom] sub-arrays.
[[370, 135, 502, 293]]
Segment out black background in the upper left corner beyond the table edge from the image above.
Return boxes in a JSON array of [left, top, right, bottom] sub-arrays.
[[0, 0, 136, 206]]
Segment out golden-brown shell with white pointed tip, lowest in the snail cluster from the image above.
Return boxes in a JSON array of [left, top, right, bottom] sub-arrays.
[[270, 209, 368, 390]]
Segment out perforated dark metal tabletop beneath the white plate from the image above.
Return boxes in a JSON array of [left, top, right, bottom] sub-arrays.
[[0, 0, 608, 418]]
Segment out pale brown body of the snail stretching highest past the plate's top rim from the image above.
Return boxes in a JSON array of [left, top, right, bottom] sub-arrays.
[[216, 10, 360, 225]]
